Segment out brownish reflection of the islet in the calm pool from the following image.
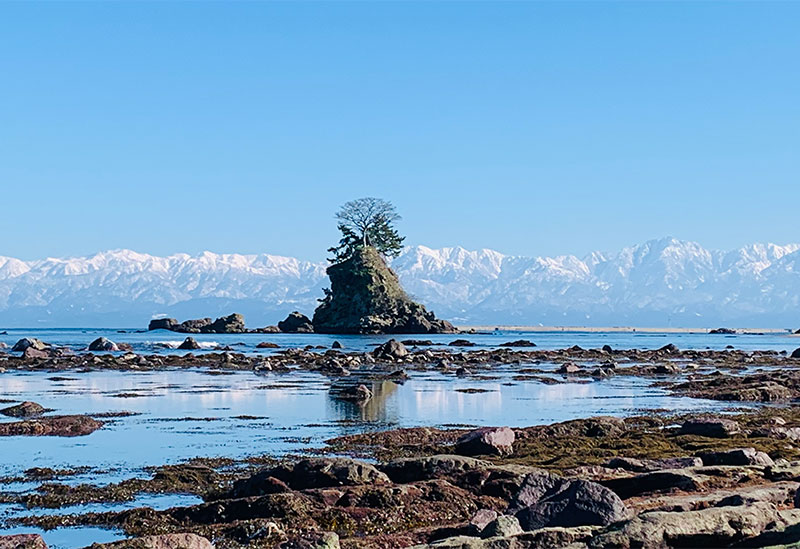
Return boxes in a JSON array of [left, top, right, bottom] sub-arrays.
[[328, 378, 398, 434]]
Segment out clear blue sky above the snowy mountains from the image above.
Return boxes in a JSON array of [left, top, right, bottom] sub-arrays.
[[0, 1, 800, 259]]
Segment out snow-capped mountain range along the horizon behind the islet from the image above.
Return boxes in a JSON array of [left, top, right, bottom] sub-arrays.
[[0, 238, 800, 328]]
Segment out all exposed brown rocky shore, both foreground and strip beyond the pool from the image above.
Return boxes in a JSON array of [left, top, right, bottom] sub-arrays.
[[0, 336, 800, 549]]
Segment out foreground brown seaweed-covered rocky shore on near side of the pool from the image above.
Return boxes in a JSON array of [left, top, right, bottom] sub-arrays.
[[7, 408, 800, 549]]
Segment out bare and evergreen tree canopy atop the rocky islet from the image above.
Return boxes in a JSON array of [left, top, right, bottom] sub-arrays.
[[328, 197, 405, 263]]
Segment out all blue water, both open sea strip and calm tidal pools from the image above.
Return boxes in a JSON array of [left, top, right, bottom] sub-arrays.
[[0, 330, 800, 549]]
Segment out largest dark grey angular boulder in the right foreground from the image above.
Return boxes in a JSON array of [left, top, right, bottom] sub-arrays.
[[508, 471, 629, 530]]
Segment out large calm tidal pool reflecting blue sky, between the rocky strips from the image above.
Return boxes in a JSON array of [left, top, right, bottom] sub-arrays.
[[0, 367, 736, 482]]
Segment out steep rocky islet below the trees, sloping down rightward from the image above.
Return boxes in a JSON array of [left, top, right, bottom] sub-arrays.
[[313, 246, 456, 334]]
